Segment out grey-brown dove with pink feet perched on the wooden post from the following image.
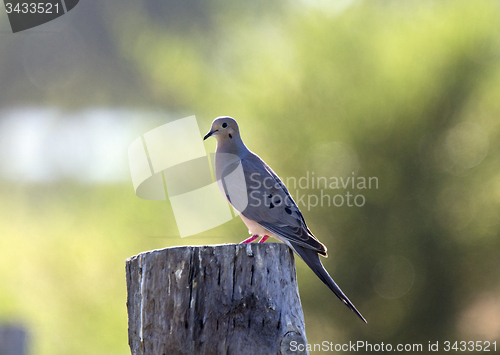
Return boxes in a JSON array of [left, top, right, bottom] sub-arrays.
[[203, 116, 367, 323]]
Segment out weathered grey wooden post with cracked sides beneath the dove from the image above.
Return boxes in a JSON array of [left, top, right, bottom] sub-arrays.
[[126, 243, 307, 355]]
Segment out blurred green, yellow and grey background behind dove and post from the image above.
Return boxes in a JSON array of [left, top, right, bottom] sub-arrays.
[[0, 0, 500, 355]]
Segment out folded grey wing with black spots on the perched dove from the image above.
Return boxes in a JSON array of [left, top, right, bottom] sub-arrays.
[[234, 154, 326, 256]]
